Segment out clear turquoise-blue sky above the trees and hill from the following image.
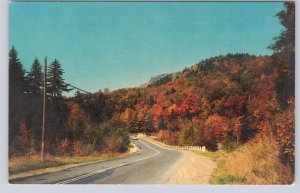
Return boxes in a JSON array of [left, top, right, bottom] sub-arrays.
[[9, 2, 283, 95]]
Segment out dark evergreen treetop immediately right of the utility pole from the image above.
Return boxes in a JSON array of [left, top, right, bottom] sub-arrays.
[[47, 59, 72, 98]]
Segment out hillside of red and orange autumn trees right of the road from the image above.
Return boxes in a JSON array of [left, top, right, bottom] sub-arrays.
[[109, 54, 294, 161]]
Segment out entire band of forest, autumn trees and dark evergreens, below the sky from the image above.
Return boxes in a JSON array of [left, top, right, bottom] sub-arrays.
[[9, 3, 295, 175]]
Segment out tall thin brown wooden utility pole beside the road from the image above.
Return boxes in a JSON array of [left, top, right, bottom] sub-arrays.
[[41, 56, 47, 161]]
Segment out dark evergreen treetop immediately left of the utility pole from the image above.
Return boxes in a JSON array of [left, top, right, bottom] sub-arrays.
[[28, 58, 44, 96]]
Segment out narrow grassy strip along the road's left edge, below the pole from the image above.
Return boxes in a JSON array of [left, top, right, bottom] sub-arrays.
[[9, 152, 129, 181]]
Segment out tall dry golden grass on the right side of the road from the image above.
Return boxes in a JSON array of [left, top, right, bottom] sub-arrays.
[[194, 136, 294, 185]]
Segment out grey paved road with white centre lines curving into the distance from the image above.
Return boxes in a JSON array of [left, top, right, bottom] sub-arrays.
[[13, 138, 184, 184]]
